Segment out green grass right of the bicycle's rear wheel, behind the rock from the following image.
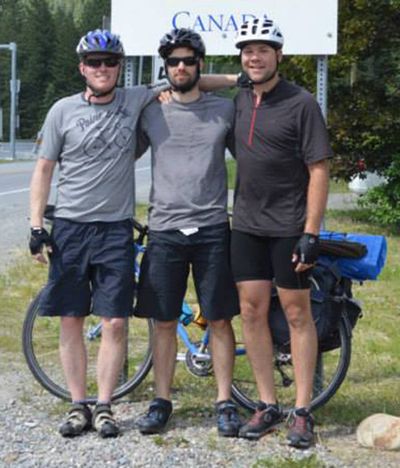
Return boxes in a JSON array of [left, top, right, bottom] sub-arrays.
[[318, 212, 400, 425]]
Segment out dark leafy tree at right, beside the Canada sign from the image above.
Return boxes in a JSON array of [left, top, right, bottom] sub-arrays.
[[282, 0, 400, 179]]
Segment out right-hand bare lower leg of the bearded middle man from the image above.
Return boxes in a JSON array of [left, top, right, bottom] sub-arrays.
[[209, 320, 235, 401]]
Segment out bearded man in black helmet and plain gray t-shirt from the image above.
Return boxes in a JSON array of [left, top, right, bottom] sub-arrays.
[[136, 28, 240, 436]]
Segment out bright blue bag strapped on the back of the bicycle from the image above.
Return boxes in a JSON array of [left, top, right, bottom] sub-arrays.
[[319, 231, 387, 281]]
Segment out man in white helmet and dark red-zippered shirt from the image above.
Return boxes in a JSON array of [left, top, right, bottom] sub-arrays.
[[232, 19, 332, 448]]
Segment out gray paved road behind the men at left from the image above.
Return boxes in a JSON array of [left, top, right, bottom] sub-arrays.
[[0, 154, 151, 271]]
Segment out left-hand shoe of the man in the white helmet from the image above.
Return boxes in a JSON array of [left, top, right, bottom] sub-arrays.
[[239, 402, 284, 440]]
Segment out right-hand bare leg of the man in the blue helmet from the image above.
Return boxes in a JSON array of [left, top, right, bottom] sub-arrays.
[[97, 317, 126, 402]]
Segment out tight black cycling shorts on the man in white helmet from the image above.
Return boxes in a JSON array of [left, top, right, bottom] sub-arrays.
[[231, 230, 311, 289]]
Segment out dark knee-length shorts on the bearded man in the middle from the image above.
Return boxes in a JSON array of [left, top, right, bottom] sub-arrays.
[[135, 223, 239, 321]]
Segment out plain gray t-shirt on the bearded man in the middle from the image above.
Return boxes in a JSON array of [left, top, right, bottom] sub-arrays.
[[137, 94, 234, 231]]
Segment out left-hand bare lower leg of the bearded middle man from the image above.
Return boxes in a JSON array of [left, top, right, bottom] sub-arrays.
[[153, 320, 178, 400]]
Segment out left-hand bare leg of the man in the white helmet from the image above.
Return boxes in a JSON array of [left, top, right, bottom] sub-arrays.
[[236, 280, 276, 403]]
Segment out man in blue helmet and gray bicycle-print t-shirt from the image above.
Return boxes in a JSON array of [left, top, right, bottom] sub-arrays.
[[30, 30, 154, 437]]
